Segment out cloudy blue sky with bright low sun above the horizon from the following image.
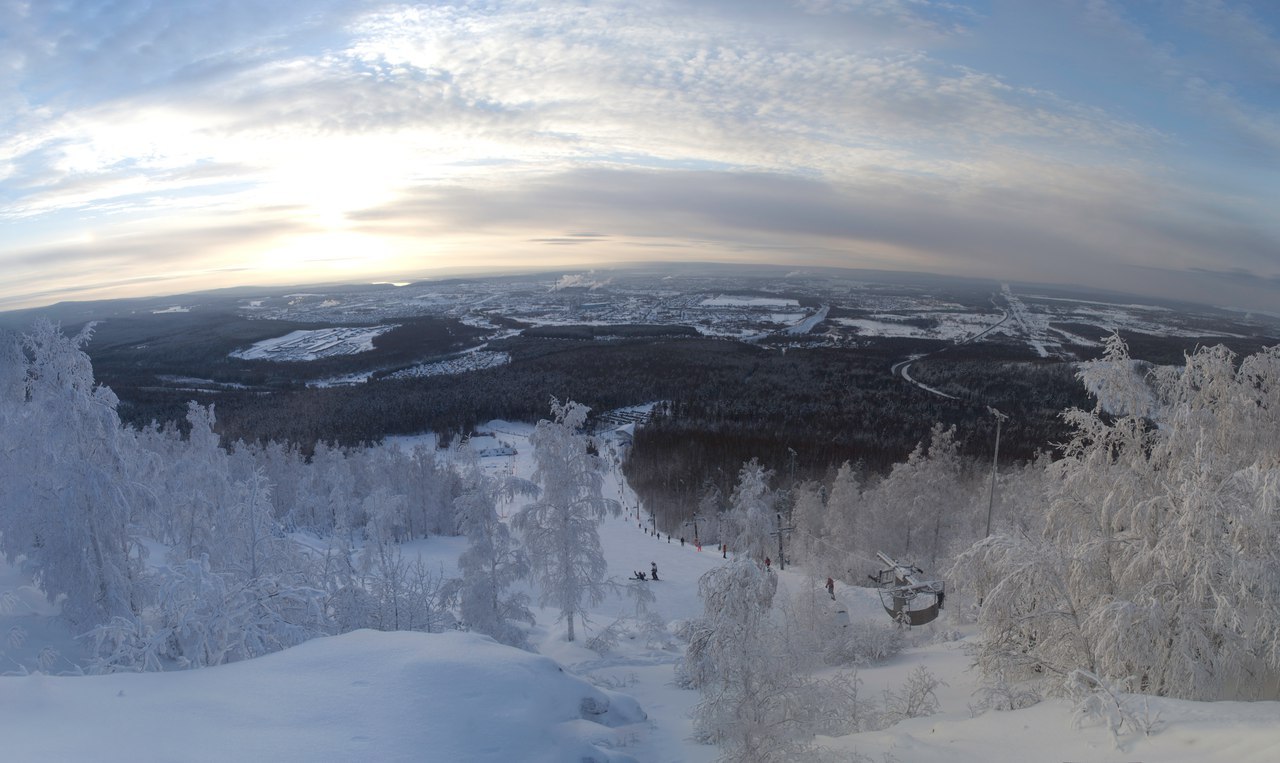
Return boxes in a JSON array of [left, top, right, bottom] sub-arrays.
[[0, 0, 1280, 310]]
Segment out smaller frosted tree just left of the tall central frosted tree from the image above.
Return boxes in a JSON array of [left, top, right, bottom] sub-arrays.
[[454, 466, 536, 647]]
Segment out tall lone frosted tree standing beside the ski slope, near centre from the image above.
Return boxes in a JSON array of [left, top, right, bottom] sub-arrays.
[[515, 399, 622, 641]]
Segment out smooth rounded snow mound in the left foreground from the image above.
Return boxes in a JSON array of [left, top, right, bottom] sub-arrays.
[[0, 630, 645, 763]]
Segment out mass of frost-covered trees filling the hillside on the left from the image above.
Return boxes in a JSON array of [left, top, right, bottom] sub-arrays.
[[0, 321, 467, 671]]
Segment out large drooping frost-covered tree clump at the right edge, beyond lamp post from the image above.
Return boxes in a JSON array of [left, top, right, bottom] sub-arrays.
[[956, 344, 1280, 699]]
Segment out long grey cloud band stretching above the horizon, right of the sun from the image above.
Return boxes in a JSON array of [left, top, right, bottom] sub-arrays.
[[352, 164, 1280, 299]]
